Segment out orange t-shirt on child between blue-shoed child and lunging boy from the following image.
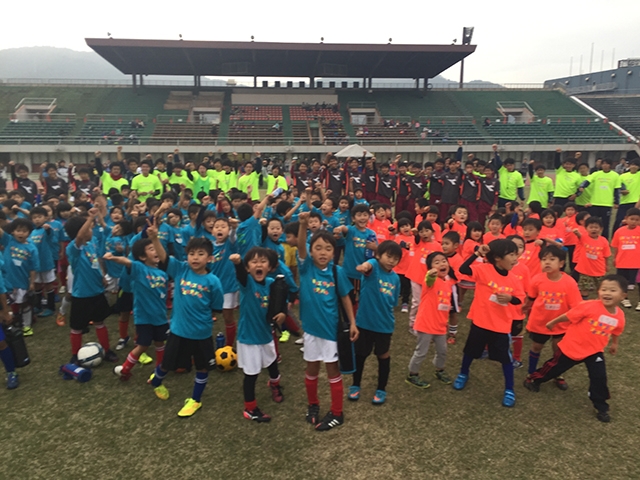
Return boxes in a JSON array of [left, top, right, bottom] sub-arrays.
[[527, 272, 582, 335]]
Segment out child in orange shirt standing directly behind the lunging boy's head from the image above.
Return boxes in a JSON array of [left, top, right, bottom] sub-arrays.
[[573, 217, 611, 300]]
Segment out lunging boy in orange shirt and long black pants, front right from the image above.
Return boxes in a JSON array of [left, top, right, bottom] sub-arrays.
[[524, 275, 628, 423]]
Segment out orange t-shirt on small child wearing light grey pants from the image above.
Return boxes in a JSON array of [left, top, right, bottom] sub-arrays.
[[413, 277, 455, 335]]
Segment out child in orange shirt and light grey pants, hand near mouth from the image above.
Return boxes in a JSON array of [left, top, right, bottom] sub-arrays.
[[405, 252, 455, 388]]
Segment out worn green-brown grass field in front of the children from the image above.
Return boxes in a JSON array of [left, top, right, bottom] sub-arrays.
[[0, 286, 640, 479]]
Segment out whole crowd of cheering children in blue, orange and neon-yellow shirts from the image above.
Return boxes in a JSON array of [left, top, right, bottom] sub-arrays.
[[0, 143, 640, 424]]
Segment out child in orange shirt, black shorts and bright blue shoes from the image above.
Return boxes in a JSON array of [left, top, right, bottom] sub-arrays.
[[453, 240, 524, 407]]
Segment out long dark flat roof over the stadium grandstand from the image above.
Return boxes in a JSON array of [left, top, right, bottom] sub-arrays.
[[85, 38, 476, 78]]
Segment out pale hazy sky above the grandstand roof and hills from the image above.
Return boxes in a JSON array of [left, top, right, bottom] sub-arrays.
[[0, 0, 640, 83]]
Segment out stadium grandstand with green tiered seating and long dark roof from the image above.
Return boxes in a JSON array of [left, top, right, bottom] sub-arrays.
[[0, 39, 640, 171]]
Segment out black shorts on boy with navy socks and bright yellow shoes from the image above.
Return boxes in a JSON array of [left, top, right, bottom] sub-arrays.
[[162, 333, 216, 371]]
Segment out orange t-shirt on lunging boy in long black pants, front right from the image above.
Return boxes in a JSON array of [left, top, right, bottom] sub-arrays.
[[558, 300, 625, 361]]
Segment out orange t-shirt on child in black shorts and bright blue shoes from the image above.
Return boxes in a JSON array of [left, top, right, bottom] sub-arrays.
[[467, 262, 524, 333]]
